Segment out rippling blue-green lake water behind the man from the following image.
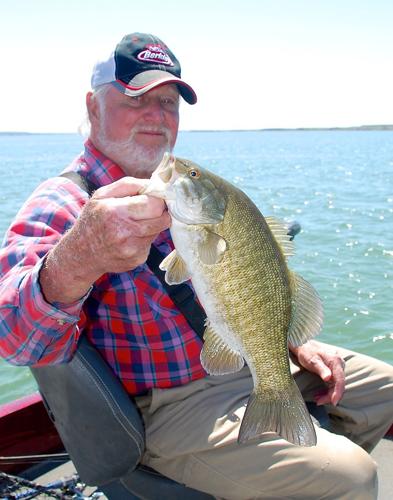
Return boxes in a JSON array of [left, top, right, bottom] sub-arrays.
[[0, 131, 393, 403]]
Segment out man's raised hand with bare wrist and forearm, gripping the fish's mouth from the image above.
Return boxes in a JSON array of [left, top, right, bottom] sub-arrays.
[[40, 177, 170, 303]]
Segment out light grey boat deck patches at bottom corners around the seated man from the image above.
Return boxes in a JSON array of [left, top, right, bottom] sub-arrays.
[[37, 438, 393, 500]]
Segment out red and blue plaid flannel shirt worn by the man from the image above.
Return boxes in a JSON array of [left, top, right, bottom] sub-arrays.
[[0, 141, 205, 395]]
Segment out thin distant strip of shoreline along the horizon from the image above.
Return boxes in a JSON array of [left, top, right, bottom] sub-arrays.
[[0, 124, 393, 136]]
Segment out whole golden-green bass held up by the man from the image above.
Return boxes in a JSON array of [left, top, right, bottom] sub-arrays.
[[143, 153, 323, 446]]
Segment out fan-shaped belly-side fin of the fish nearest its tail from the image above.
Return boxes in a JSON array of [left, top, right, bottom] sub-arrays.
[[201, 325, 244, 375]]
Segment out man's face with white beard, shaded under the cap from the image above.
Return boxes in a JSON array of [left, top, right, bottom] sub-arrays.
[[91, 84, 179, 177]]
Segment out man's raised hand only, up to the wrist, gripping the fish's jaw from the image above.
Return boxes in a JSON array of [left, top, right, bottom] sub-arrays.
[[81, 177, 170, 276]]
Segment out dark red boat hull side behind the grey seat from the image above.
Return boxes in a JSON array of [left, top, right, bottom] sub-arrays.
[[0, 393, 393, 474]]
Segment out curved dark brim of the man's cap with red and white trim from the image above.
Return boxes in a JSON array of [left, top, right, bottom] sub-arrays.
[[111, 70, 197, 104]]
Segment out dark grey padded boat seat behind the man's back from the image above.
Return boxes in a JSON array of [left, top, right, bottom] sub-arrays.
[[31, 336, 213, 500]]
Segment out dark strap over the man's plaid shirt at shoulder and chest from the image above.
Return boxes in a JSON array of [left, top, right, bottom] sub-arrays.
[[60, 172, 206, 340]]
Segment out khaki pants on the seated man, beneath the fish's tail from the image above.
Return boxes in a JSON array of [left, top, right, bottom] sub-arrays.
[[138, 349, 393, 500]]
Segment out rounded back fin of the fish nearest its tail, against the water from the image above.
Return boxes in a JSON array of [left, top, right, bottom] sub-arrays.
[[288, 273, 323, 346]]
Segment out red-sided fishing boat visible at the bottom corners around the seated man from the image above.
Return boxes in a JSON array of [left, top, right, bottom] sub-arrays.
[[0, 392, 393, 500]]
